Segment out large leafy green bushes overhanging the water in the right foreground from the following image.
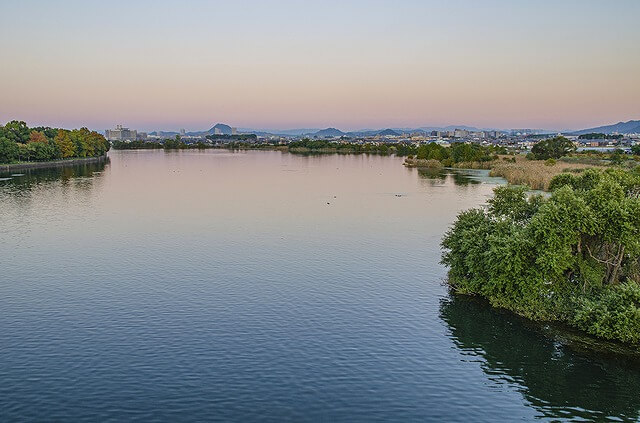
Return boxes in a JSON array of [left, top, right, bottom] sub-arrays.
[[442, 169, 640, 343]]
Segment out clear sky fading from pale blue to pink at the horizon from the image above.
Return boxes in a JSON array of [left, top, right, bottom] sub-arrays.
[[0, 0, 640, 131]]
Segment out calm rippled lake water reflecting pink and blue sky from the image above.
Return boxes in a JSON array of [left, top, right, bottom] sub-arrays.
[[0, 150, 640, 422]]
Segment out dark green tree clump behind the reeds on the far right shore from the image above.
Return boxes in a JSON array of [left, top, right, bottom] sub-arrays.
[[416, 142, 506, 166]]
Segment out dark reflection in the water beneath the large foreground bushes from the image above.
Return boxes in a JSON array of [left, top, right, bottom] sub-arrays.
[[440, 296, 640, 421]]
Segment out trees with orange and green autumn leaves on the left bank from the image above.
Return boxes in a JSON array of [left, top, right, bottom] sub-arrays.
[[0, 120, 110, 163]]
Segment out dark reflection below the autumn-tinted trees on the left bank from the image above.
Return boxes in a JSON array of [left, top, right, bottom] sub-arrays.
[[0, 157, 110, 191]]
